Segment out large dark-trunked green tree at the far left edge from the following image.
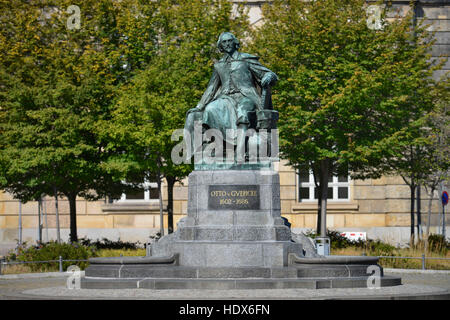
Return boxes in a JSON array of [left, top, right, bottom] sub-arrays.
[[0, 0, 152, 241]]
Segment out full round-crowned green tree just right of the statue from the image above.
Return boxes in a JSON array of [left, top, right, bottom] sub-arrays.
[[252, 0, 442, 240]]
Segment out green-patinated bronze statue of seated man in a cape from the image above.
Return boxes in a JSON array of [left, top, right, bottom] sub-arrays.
[[185, 32, 278, 164]]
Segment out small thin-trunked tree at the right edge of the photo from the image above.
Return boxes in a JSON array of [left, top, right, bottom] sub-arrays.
[[388, 84, 450, 247]]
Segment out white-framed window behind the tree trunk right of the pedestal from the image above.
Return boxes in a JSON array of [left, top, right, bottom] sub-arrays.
[[297, 170, 350, 202]]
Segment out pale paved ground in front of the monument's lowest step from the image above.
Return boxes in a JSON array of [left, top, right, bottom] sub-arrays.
[[0, 272, 450, 300]]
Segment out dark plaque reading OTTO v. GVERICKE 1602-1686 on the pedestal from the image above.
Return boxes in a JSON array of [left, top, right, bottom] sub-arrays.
[[208, 184, 260, 210]]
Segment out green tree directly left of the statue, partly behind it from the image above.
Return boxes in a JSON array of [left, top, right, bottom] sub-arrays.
[[102, 0, 248, 234]]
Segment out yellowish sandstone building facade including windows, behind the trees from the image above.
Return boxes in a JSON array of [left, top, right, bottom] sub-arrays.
[[0, 0, 450, 255]]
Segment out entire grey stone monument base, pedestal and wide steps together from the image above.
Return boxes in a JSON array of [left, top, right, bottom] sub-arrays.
[[81, 170, 401, 289]]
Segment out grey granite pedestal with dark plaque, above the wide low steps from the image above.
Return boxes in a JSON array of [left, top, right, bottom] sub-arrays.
[[152, 170, 302, 267]]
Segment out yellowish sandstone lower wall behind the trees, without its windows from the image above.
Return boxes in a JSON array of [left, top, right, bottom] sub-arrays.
[[0, 161, 450, 244]]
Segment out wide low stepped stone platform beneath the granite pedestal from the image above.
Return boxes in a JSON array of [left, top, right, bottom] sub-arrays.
[[81, 256, 401, 290]]
